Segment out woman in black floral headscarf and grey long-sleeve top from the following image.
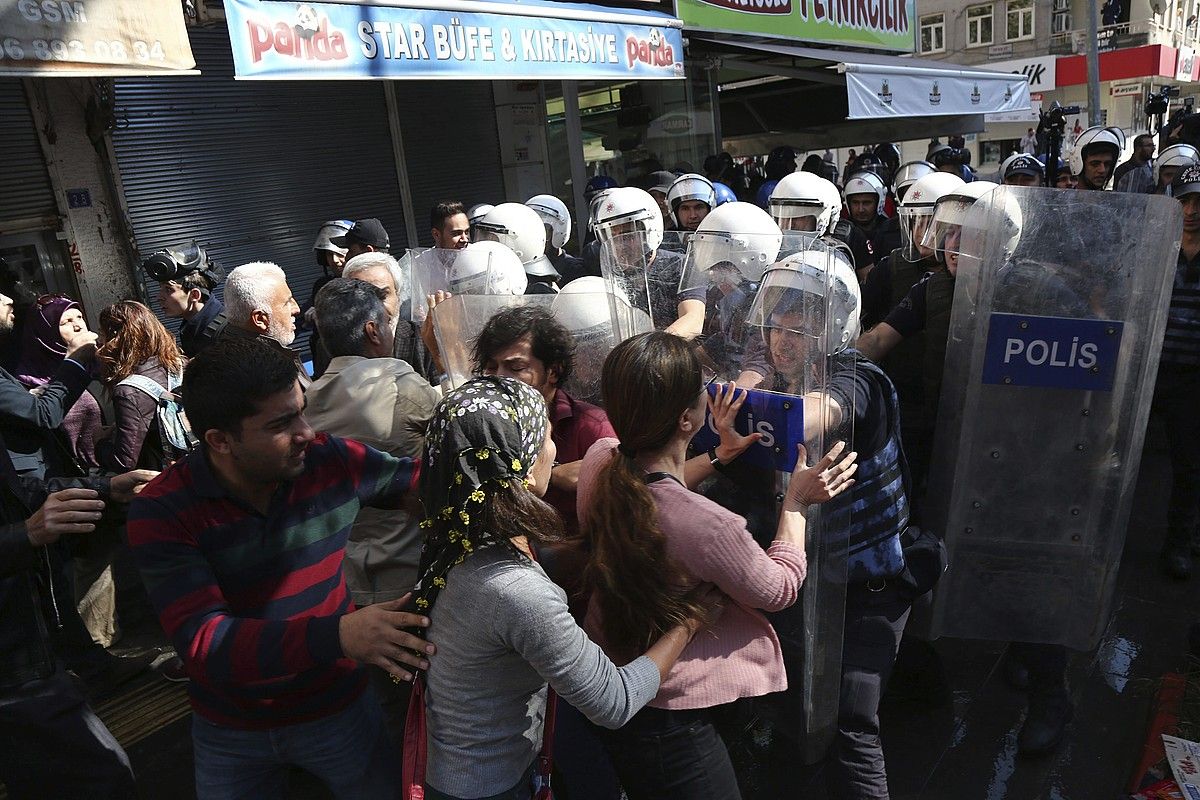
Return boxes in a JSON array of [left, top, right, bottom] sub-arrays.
[[416, 378, 713, 800]]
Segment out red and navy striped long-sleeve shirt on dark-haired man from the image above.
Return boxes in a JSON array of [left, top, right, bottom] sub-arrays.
[[128, 434, 416, 729]]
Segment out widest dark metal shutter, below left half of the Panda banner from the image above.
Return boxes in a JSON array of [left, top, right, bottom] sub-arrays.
[[113, 28, 407, 350]]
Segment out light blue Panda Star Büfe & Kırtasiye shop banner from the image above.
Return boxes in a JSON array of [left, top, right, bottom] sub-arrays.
[[224, 0, 683, 80]]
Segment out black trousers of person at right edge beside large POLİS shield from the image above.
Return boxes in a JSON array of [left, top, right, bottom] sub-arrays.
[[1154, 365, 1200, 552]]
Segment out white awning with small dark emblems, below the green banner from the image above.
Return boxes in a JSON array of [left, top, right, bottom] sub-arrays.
[[692, 36, 1030, 120]]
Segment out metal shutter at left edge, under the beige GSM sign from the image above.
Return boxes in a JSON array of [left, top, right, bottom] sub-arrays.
[[0, 78, 59, 230]]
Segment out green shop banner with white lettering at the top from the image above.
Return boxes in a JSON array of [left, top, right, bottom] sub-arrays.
[[676, 0, 917, 53]]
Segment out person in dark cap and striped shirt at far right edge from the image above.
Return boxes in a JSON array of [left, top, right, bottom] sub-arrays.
[[1154, 167, 1200, 581]]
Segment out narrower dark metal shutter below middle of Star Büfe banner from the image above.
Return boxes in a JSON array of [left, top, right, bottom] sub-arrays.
[[395, 80, 506, 247]]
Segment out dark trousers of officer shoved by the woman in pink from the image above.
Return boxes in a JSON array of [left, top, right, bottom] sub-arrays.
[[826, 583, 911, 800]]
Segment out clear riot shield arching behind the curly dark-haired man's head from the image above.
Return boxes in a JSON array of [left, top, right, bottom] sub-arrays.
[[432, 284, 630, 405]]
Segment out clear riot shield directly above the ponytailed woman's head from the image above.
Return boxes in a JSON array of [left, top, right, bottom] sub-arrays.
[[600, 230, 703, 338]]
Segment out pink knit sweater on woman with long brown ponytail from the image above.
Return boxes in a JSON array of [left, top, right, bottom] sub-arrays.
[[578, 439, 806, 709]]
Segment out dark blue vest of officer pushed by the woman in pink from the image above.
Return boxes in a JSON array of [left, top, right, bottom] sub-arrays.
[[824, 350, 910, 583]]
